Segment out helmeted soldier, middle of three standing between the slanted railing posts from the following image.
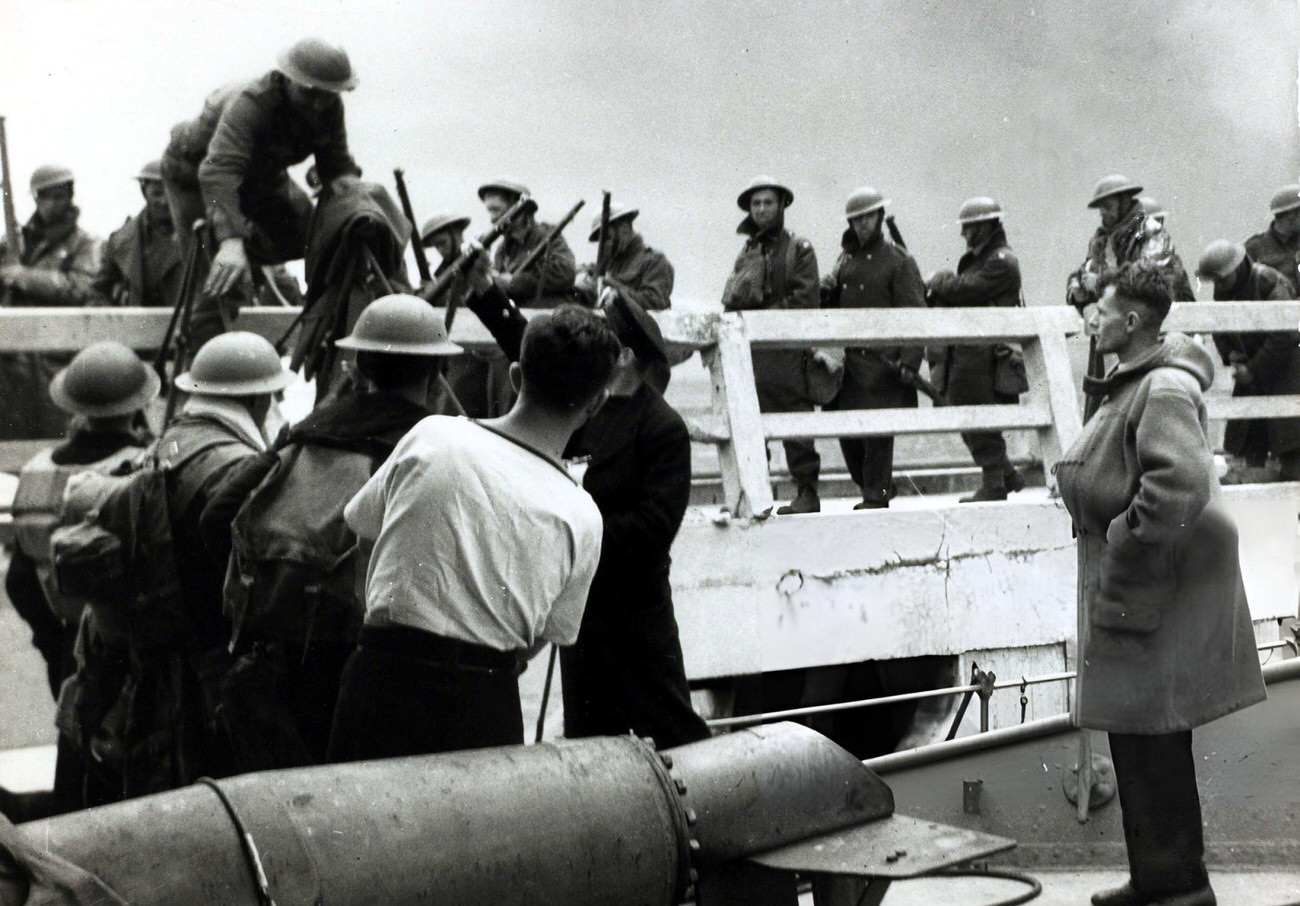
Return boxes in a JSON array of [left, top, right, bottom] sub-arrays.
[[822, 186, 926, 510]]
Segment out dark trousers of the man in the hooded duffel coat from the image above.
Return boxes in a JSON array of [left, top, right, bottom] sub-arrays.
[[1110, 731, 1209, 900]]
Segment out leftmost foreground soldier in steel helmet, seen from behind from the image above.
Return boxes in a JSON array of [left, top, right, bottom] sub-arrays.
[[0, 342, 160, 820]]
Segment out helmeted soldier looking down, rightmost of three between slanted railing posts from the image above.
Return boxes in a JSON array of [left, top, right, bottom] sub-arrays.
[[928, 198, 1024, 503]]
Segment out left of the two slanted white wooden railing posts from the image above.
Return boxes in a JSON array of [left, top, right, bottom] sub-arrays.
[[701, 315, 772, 517]]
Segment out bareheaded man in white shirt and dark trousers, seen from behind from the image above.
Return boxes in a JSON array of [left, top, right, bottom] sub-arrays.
[[329, 301, 619, 760]]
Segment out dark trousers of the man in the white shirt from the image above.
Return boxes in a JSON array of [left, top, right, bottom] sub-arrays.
[[328, 627, 524, 762]]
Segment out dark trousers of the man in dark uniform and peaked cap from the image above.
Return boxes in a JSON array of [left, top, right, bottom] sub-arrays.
[[560, 592, 710, 749]]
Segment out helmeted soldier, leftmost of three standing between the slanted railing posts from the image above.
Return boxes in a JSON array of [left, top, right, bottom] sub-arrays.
[[723, 177, 821, 513]]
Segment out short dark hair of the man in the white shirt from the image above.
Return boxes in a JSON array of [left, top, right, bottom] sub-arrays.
[[519, 304, 623, 412]]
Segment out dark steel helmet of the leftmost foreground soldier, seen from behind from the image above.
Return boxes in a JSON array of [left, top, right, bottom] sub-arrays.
[[49, 341, 161, 419]]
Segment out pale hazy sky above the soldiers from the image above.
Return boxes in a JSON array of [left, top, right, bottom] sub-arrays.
[[0, 0, 1300, 307]]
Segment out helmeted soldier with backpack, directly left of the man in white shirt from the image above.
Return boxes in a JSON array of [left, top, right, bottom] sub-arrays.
[[200, 295, 460, 773]]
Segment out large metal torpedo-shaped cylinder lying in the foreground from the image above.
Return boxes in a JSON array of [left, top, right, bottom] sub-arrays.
[[0, 724, 893, 906]]
